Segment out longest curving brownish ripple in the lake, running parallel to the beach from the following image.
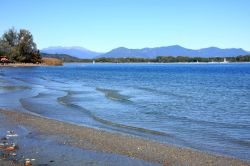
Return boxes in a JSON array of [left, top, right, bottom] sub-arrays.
[[58, 93, 169, 137]]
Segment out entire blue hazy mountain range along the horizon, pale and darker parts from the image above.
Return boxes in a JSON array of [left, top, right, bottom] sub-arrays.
[[41, 45, 249, 59]]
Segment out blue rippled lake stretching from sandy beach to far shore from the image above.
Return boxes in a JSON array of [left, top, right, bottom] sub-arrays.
[[0, 64, 250, 160]]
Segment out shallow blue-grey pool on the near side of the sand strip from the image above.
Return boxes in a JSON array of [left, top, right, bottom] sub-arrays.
[[0, 112, 160, 166]]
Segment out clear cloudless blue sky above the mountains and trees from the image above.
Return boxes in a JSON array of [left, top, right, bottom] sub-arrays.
[[0, 0, 250, 52]]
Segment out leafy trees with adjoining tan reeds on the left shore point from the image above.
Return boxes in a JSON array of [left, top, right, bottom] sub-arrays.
[[0, 28, 63, 66]]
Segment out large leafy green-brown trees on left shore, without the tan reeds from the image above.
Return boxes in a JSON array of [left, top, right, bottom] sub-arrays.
[[0, 28, 41, 63]]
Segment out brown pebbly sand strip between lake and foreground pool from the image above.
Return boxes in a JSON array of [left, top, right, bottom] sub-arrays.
[[0, 110, 250, 166]]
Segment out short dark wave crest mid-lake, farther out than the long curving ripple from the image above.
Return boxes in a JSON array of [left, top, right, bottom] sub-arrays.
[[96, 88, 132, 102]]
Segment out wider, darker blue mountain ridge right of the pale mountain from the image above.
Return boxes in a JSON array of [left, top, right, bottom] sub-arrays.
[[98, 45, 249, 58]]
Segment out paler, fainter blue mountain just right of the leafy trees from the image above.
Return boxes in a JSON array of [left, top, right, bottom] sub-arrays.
[[41, 46, 102, 59]]
